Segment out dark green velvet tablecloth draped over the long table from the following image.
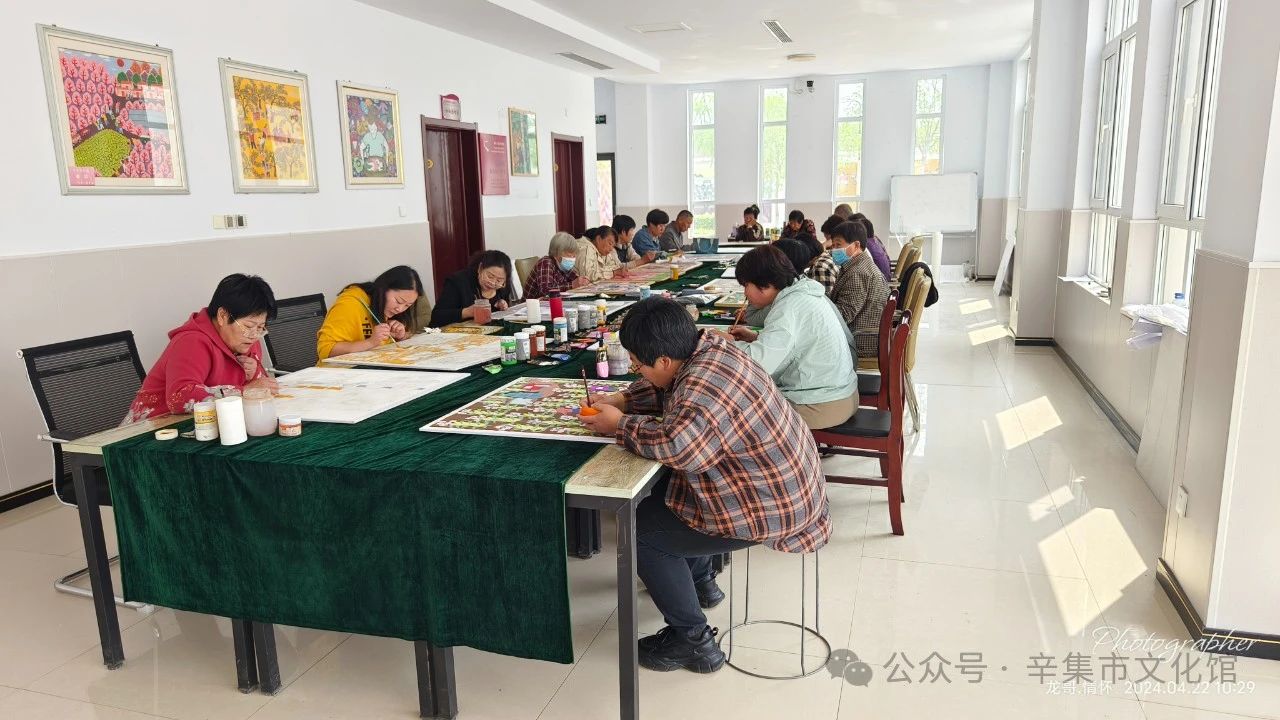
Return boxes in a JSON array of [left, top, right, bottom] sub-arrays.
[[104, 256, 737, 662]]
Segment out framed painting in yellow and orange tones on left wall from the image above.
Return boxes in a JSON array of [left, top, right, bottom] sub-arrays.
[[218, 58, 320, 192]]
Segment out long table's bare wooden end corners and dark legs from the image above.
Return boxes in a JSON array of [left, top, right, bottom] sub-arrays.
[[63, 415, 662, 720]]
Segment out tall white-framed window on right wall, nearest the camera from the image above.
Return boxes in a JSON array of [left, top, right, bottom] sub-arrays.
[[1152, 0, 1224, 304]]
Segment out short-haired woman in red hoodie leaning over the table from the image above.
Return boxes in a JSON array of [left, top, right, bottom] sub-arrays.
[[123, 273, 276, 424]]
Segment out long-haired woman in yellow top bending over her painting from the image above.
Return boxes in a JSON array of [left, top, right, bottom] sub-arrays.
[[316, 265, 422, 360]]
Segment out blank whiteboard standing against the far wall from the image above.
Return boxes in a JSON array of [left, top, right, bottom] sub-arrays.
[[888, 173, 978, 234]]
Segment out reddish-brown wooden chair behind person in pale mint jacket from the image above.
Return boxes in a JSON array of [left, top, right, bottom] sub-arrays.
[[813, 319, 911, 536]]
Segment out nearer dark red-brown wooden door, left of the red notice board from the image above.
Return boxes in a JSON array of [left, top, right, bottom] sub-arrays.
[[422, 118, 484, 297]]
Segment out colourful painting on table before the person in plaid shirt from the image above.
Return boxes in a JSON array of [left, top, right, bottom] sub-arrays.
[[420, 378, 631, 443]]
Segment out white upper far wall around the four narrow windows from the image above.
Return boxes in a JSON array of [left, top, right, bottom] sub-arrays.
[[604, 61, 1012, 252]]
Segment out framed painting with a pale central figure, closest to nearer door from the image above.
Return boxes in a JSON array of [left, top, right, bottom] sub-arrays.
[[338, 81, 404, 187]]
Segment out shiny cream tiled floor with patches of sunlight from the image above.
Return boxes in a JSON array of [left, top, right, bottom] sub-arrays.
[[0, 284, 1280, 720]]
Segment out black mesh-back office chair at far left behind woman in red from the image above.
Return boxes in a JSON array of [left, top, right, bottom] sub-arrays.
[[18, 331, 147, 609]]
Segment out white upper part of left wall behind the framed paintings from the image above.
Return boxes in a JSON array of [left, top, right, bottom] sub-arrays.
[[0, 0, 595, 256]]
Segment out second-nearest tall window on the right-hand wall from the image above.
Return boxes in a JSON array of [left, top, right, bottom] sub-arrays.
[[1088, 0, 1138, 288]]
